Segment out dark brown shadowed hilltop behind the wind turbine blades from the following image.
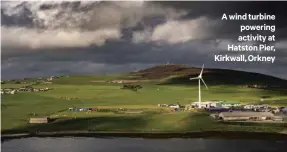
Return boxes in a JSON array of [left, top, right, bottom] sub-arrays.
[[132, 65, 287, 88]]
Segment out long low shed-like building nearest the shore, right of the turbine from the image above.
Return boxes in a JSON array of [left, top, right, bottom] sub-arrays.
[[218, 111, 280, 121]]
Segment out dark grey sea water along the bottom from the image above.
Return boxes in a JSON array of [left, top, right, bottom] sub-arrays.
[[1, 137, 287, 152]]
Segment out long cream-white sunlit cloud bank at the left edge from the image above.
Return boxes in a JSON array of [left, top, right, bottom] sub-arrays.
[[1, 26, 121, 49]]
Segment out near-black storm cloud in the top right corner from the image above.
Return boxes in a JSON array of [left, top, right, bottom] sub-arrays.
[[157, 1, 287, 39]]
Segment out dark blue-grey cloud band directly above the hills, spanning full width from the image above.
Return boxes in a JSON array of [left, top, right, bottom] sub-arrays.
[[2, 39, 287, 79]]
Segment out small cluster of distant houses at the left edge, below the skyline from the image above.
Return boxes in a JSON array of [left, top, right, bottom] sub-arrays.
[[1, 86, 51, 94]]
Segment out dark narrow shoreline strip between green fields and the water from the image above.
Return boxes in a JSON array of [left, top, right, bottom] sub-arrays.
[[1, 131, 287, 142]]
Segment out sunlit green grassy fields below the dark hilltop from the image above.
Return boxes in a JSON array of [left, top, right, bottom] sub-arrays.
[[1, 75, 287, 133]]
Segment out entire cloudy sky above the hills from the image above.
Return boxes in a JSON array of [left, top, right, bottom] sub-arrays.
[[1, 1, 287, 80]]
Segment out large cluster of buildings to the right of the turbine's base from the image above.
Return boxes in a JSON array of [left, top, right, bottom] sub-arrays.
[[188, 101, 287, 123]]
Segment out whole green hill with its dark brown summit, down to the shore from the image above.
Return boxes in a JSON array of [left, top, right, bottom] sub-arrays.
[[1, 65, 287, 133]]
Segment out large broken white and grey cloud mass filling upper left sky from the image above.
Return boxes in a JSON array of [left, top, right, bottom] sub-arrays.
[[1, 1, 189, 49]]
